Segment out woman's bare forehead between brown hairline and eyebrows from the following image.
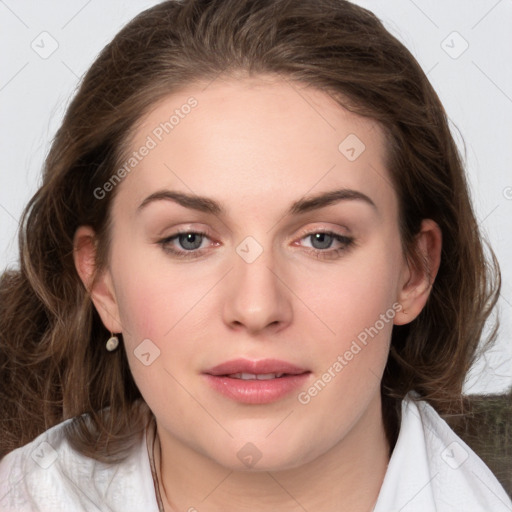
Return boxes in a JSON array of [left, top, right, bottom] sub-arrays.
[[116, 76, 396, 219]]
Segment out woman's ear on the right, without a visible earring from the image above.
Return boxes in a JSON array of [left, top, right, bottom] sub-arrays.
[[394, 219, 442, 325]]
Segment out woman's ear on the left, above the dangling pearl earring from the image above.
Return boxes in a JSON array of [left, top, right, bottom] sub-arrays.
[[73, 226, 123, 333]]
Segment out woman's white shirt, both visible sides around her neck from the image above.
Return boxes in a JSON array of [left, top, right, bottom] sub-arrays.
[[0, 394, 512, 512]]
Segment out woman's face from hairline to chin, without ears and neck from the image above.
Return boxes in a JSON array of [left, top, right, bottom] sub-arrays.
[[86, 77, 409, 469]]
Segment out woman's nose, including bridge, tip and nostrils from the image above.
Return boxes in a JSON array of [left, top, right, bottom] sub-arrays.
[[224, 237, 292, 331]]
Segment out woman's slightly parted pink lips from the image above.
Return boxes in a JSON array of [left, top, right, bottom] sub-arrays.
[[204, 359, 311, 404]]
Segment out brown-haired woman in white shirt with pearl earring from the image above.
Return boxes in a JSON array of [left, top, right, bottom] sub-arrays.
[[0, 0, 512, 512]]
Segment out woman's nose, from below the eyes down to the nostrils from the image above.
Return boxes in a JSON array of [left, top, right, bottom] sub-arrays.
[[223, 241, 293, 334]]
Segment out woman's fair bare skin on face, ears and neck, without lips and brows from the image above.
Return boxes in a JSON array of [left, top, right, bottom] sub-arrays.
[[75, 76, 441, 512]]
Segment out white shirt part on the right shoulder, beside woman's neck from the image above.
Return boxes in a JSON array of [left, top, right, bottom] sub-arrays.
[[375, 393, 512, 512]]
